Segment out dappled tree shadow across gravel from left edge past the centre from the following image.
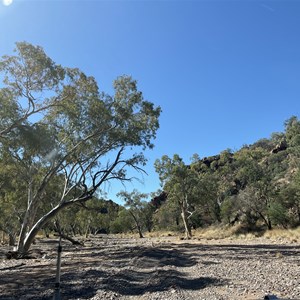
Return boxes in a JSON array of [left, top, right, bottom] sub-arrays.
[[0, 245, 225, 300]]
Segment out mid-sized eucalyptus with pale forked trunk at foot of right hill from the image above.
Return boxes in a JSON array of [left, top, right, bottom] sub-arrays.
[[155, 154, 199, 239]]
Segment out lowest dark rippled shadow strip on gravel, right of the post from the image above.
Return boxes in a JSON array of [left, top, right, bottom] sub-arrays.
[[56, 270, 226, 299]]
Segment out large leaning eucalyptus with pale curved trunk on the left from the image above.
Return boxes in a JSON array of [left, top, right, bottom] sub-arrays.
[[0, 42, 161, 255]]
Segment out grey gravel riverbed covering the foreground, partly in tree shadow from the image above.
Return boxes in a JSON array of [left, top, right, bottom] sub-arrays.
[[0, 236, 300, 300]]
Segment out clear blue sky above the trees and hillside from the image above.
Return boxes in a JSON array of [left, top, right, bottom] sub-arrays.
[[0, 0, 300, 202]]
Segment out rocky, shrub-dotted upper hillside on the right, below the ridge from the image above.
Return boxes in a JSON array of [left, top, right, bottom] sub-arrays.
[[185, 139, 298, 204]]
